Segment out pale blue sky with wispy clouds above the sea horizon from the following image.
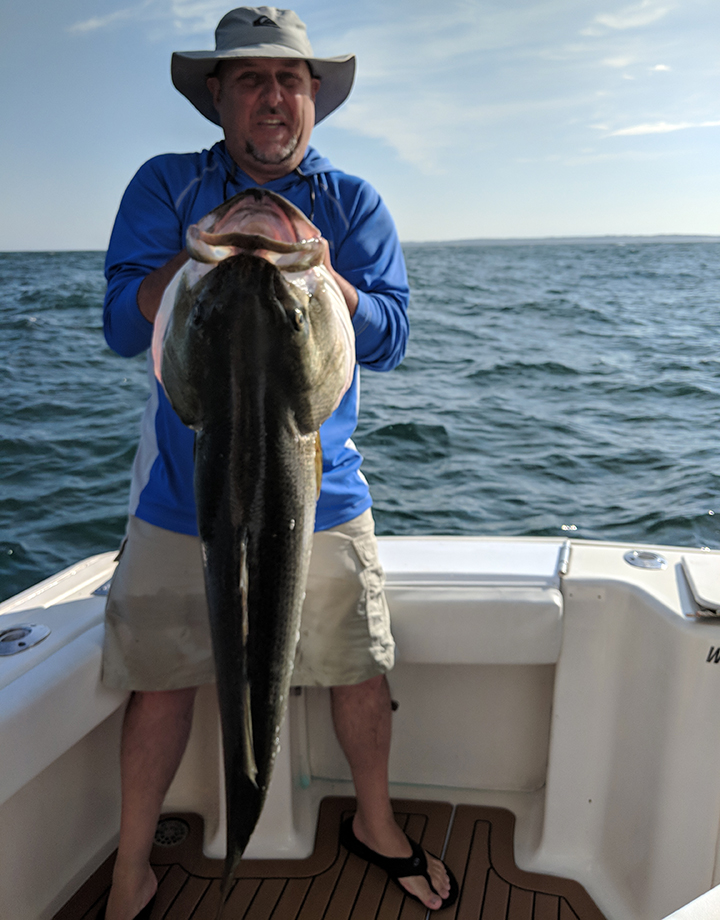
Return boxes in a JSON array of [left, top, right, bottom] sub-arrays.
[[0, 0, 720, 251]]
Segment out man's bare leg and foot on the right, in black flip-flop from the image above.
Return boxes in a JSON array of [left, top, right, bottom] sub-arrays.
[[331, 675, 450, 910]]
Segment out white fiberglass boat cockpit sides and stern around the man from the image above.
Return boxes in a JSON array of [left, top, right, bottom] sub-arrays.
[[0, 538, 720, 920]]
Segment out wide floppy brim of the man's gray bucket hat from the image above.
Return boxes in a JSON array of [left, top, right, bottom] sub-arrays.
[[170, 45, 355, 125]]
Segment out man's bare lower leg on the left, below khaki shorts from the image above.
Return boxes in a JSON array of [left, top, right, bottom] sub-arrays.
[[105, 687, 196, 920]]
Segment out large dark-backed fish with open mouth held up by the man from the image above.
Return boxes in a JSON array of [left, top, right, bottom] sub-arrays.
[[152, 189, 355, 910]]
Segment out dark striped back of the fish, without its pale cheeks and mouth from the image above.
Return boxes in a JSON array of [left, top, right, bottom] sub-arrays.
[[195, 255, 317, 876]]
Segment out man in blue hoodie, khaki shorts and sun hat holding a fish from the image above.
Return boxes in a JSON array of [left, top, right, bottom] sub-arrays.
[[103, 7, 456, 920]]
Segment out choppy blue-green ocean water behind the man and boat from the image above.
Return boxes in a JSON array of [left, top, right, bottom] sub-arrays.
[[0, 239, 720, 599]]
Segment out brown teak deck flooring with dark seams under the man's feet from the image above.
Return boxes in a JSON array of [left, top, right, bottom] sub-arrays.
[[54, 798, 605, 920]]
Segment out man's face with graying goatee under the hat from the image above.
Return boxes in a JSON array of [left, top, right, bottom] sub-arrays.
[[207, 58, 320, 184]]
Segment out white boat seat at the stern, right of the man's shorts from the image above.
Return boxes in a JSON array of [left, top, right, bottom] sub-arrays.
[[380, 537, 564, 665]]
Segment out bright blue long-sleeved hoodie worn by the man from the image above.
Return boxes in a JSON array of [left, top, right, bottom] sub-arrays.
[[103, 141, 409, 535]]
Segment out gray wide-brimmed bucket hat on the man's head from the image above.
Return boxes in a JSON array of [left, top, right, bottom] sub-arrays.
[[170, 6, 355, 125]]
